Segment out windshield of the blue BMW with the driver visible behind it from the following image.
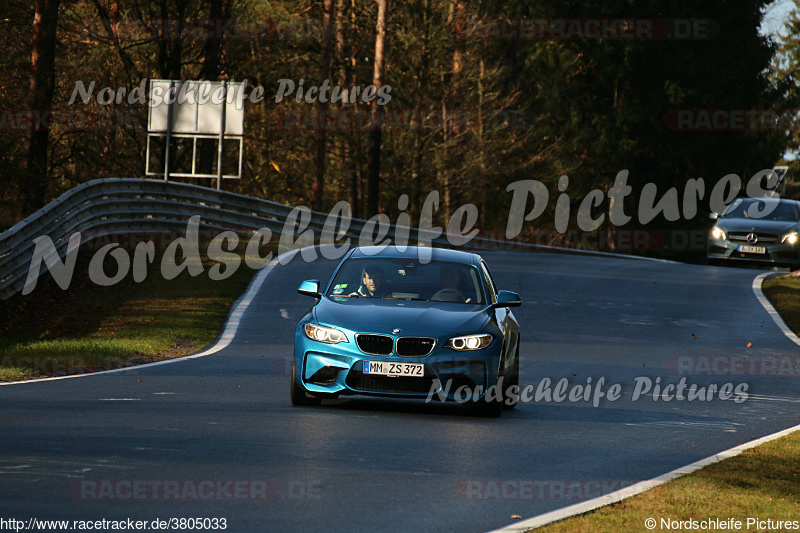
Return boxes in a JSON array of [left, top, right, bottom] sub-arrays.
[[328, 257, 485, 304]]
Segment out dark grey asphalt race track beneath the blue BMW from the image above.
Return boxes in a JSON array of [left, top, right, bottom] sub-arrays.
[[0, 252, 800, 532]]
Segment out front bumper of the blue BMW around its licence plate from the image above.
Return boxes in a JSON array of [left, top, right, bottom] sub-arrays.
[[294, 328, 502, 400]]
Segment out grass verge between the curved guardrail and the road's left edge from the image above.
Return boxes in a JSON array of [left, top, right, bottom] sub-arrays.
[[0, 243, 264, 381]]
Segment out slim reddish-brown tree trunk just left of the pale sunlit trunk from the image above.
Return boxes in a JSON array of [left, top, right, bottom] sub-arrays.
[[311, 0, 333, 211]]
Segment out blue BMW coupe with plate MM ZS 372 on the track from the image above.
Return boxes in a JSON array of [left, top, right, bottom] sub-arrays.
[[291, 247, 522, 416]]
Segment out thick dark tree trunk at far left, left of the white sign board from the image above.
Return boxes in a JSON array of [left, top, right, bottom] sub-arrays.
[[23, 0, 59, 214]]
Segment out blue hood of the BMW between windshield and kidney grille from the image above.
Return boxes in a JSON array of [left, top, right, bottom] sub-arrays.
[[314, 298, 491, 337]]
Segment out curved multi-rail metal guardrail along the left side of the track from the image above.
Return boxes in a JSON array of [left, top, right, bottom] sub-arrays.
[[0, 178, 462, 300]]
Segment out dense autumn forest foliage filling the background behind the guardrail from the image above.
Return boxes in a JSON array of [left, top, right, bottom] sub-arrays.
[[0, 0, 797, 254]]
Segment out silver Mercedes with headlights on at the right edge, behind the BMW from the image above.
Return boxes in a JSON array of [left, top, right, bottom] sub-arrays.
[[707, 198, 800, 268]]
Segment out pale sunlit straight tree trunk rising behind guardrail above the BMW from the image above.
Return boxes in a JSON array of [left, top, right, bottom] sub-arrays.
[[367, 0, 387, 216]]
